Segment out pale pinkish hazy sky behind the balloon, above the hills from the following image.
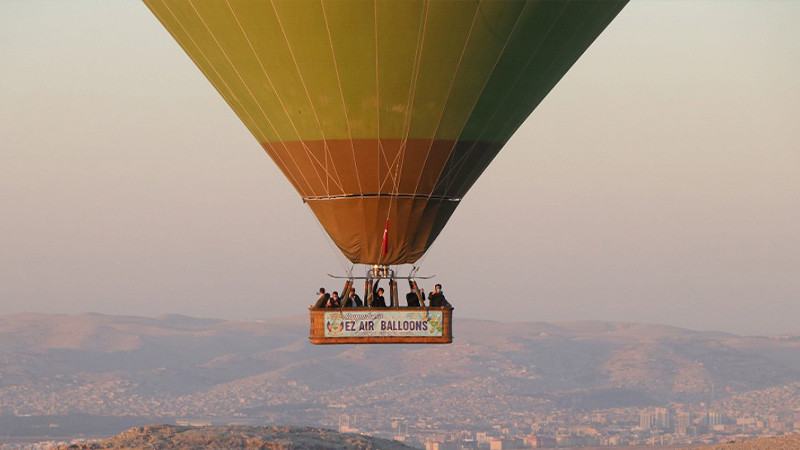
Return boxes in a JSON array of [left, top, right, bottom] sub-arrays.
[[0, 0, 800, 337]]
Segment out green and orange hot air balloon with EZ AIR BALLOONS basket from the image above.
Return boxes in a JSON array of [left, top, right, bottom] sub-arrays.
[[144, 0, 627, 343]]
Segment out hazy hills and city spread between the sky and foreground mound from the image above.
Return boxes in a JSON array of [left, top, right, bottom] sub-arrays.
[[0, 314, 800, 447]]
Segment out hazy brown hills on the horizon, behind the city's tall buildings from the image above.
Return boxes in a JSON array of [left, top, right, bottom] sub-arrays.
[[0, 314, 800, 424]]
